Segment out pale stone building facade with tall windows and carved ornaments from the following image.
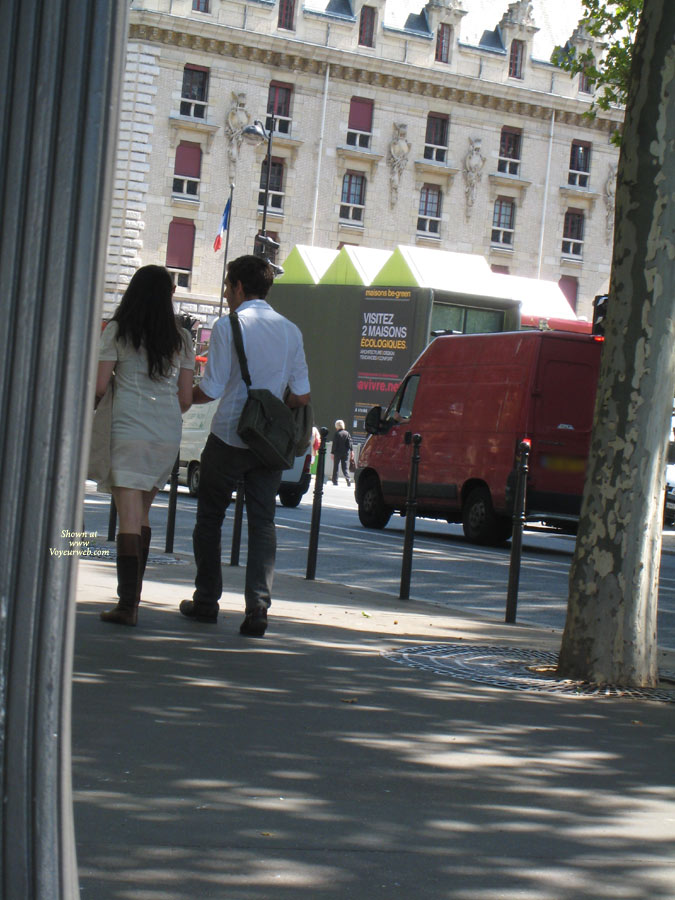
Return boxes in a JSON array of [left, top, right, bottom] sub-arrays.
[[105, 0, 622, 317]]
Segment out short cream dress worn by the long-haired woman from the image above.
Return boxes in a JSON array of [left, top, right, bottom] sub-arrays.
[[98, 321, 195, 493]]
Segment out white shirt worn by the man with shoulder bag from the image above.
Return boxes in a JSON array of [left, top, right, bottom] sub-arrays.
[[200, 300, 310, 447]]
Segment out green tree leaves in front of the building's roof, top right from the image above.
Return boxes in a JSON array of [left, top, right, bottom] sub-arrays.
[[553, 0, 643, 117]]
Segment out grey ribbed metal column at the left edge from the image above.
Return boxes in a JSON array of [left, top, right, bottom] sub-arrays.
[[0, 0, 129, 900]]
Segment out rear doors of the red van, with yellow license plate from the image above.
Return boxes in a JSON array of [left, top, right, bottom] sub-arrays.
[[527, 335, 602, 516]]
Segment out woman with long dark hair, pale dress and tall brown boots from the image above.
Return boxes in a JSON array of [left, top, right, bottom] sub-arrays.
[[96, 266, 195, 625]]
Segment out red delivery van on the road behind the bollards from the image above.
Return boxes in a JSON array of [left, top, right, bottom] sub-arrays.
[[356, 331, 602, 544]]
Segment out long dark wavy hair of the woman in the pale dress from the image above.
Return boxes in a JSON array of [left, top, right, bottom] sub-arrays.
[[112, 266, 184, 381]]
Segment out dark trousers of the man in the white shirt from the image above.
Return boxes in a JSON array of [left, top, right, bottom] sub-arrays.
[[192, 434, 281, 613]]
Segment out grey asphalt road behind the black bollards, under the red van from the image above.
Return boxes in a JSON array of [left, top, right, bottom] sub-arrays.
[[85, 484, 675, 649]]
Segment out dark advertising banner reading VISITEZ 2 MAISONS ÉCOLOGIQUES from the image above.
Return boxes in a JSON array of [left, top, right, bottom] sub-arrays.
[[352, 287, 415, 438]]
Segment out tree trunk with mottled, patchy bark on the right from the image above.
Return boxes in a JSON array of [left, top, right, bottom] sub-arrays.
[[558, 0, 675, 686]]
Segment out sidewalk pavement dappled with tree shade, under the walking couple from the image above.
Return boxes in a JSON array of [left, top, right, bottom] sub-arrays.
[[73, 548, 675, 900]]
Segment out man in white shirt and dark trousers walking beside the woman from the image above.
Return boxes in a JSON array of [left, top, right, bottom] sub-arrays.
[[180, 256, 310, 637]]
